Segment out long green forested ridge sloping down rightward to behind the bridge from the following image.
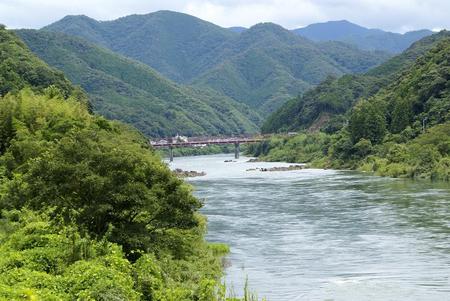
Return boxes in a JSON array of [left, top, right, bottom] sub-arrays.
[[17, 30, 259, 137]]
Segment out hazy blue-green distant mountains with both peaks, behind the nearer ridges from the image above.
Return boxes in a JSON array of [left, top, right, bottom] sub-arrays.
[[44, 11, 389, 115]]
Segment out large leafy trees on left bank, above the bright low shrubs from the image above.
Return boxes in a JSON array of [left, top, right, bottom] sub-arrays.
[[0, 92, 201, 254]]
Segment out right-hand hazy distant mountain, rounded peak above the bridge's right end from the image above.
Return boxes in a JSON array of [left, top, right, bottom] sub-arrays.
[[194, 23, 389, 115]]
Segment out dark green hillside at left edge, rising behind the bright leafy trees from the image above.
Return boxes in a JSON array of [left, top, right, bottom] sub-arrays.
[[0, 26, 89, 154]]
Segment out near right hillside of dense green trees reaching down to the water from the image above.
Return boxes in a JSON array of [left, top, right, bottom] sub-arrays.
[[249, 33, 450, 181]]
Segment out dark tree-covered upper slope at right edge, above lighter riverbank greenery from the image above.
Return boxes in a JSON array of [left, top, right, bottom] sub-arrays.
[[362, 34, 450, 135]]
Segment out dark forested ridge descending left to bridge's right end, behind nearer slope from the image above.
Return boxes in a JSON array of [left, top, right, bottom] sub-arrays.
[[262, 31, 450, 132]]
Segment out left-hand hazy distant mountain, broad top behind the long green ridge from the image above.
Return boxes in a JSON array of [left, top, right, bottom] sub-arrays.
[[43, 11, 237, 82]]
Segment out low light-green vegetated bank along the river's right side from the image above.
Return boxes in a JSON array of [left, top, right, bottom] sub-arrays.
[[247, 123, 450, 182]]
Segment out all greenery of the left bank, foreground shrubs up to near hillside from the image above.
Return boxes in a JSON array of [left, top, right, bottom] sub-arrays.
[[0, 27, 266, 301]]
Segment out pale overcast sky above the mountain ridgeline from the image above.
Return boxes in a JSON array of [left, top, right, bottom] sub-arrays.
[[0, 0, 450, 32]]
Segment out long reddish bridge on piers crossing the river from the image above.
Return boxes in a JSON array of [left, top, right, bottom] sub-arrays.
[[150, 136, 268, 162]]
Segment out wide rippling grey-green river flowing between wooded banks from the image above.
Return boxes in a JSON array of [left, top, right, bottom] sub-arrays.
[[170, 155, 450, 301]]
